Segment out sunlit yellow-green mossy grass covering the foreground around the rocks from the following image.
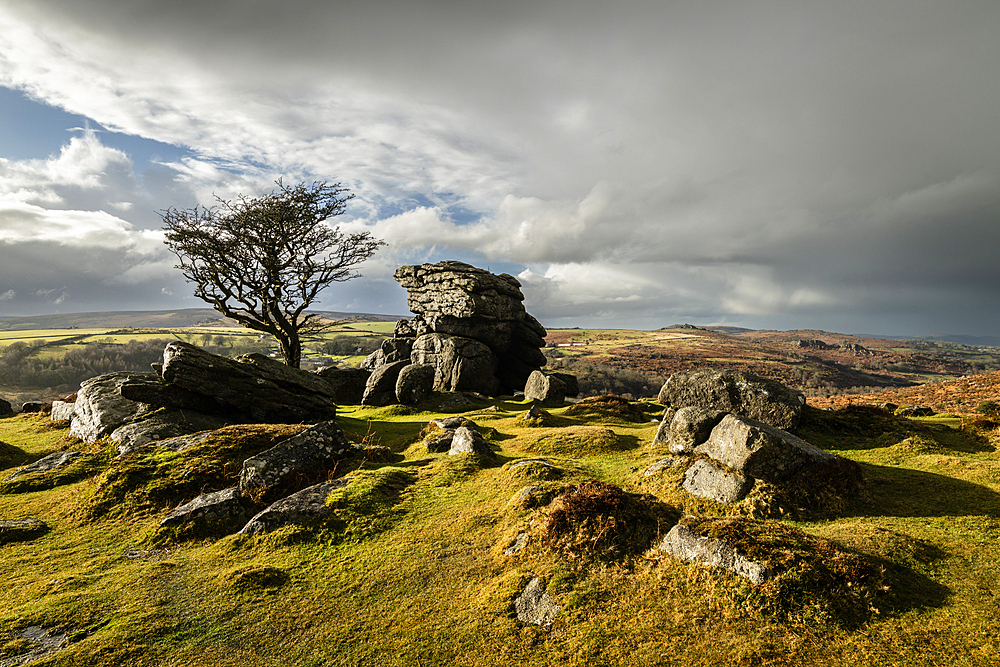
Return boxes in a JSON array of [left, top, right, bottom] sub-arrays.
[[0, 401, 1000, 667]]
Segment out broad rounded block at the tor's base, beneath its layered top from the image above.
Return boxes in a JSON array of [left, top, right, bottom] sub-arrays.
[[410, 333, 499, 394]]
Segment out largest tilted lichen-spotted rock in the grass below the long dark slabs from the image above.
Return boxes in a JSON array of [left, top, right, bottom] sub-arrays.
[[239, 421, 357, 503]]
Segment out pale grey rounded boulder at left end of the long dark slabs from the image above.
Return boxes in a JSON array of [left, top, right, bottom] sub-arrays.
[[69, 373, 153, 442]]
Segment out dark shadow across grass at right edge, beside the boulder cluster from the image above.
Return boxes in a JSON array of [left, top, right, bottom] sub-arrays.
[[849, 463, 1000, 517]]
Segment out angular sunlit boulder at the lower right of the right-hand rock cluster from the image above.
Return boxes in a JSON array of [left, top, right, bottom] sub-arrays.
[[695, 414, 837, 484]]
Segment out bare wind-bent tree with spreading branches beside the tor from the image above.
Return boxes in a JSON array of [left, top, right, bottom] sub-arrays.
[[160, 180, 385, 368]]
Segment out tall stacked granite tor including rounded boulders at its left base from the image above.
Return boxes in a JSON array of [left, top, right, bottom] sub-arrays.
[[362, 261, 546, 405]]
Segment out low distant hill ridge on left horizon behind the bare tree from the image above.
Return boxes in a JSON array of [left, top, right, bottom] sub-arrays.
[[0, 308, 405, 331]]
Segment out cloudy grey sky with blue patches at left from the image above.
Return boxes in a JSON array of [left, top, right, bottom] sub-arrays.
[[0, 0, 1000, 336]]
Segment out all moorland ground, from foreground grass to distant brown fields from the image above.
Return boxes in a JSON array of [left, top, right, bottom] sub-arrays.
[[0, 314, 1000, 666]]
